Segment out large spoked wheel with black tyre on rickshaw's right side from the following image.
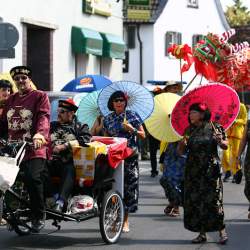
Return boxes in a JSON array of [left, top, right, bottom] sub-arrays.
[[99, 190, 124, 244]]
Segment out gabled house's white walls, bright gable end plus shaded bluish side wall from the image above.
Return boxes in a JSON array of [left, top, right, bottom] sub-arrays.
[[123, 0, 229, 87]]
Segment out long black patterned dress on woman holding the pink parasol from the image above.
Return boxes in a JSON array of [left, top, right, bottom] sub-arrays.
[[184, 123, 226, 232]]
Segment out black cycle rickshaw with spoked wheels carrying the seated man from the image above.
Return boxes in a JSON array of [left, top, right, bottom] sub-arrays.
[[2, 138, 126, 244]]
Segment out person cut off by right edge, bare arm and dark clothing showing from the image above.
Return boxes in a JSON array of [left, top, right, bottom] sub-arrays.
[[236, 117, 250, 219]]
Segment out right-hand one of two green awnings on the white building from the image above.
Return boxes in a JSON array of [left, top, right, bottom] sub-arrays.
[[101, 33, 125, 59]]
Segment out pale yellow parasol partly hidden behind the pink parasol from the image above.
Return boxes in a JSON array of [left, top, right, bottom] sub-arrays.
[[145, 93, 181, 142]]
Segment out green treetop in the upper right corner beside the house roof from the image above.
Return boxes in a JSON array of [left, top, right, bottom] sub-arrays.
[[225, 0, 250, 27]]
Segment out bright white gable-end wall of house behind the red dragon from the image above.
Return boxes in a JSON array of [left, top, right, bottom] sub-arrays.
[[154, 0, 229, 86]]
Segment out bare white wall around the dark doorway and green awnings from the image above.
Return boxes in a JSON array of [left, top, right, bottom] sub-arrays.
[[0, 0, 123, 90]]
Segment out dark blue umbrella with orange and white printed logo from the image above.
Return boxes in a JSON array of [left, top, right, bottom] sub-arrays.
[[62, 75, 112, 92]]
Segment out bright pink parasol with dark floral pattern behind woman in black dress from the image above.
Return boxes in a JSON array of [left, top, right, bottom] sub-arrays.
[[171, 83, 240, 136]]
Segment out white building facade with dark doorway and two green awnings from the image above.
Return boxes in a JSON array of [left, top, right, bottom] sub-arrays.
[[0, 0, 125, 90]]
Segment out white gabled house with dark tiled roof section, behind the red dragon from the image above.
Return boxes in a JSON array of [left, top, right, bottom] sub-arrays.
[[123, 0, 229, 89]]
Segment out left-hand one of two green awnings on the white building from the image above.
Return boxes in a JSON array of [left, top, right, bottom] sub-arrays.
[[71, 26, 103, 56]]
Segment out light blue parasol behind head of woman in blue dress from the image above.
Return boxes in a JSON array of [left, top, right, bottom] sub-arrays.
[[97, 81, 154, 121]]
